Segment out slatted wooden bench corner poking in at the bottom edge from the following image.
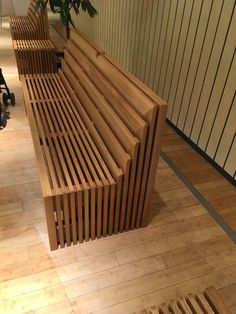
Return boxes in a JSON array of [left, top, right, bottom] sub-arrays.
[[134, 287, 231, 314]]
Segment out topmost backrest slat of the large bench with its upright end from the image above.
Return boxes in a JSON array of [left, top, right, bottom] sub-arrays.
[[70, 30, 167, 228]]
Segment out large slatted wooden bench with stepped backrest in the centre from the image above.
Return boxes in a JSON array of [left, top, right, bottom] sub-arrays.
[[21, 31, 166, 249]]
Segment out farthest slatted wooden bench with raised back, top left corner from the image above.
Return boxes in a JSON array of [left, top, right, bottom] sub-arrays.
[[10, 0, 49, 40]]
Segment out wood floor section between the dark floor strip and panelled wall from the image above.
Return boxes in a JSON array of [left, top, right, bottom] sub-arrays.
[[162, 125, 236, 231]]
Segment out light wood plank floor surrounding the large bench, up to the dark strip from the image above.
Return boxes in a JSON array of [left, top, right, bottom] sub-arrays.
[[0, 17, 236, 314]]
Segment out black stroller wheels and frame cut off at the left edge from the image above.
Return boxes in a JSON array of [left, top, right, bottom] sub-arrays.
[[0, 68, 15, 130]]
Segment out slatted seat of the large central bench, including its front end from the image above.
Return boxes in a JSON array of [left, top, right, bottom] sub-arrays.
[[21, 74, 123, 250]]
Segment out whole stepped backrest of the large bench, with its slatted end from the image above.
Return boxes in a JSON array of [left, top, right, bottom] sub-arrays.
[[60, 31, 166, 231]]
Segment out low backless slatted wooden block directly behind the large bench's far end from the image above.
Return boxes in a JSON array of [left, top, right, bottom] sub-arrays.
[[13, 39, 55, 75]]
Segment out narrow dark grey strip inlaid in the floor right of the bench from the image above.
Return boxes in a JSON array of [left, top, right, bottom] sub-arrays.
[[161, 151, 236, 243]]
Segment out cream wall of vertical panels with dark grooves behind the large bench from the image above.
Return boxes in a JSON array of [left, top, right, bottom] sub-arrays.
[[76, 0, 236, 182]]
